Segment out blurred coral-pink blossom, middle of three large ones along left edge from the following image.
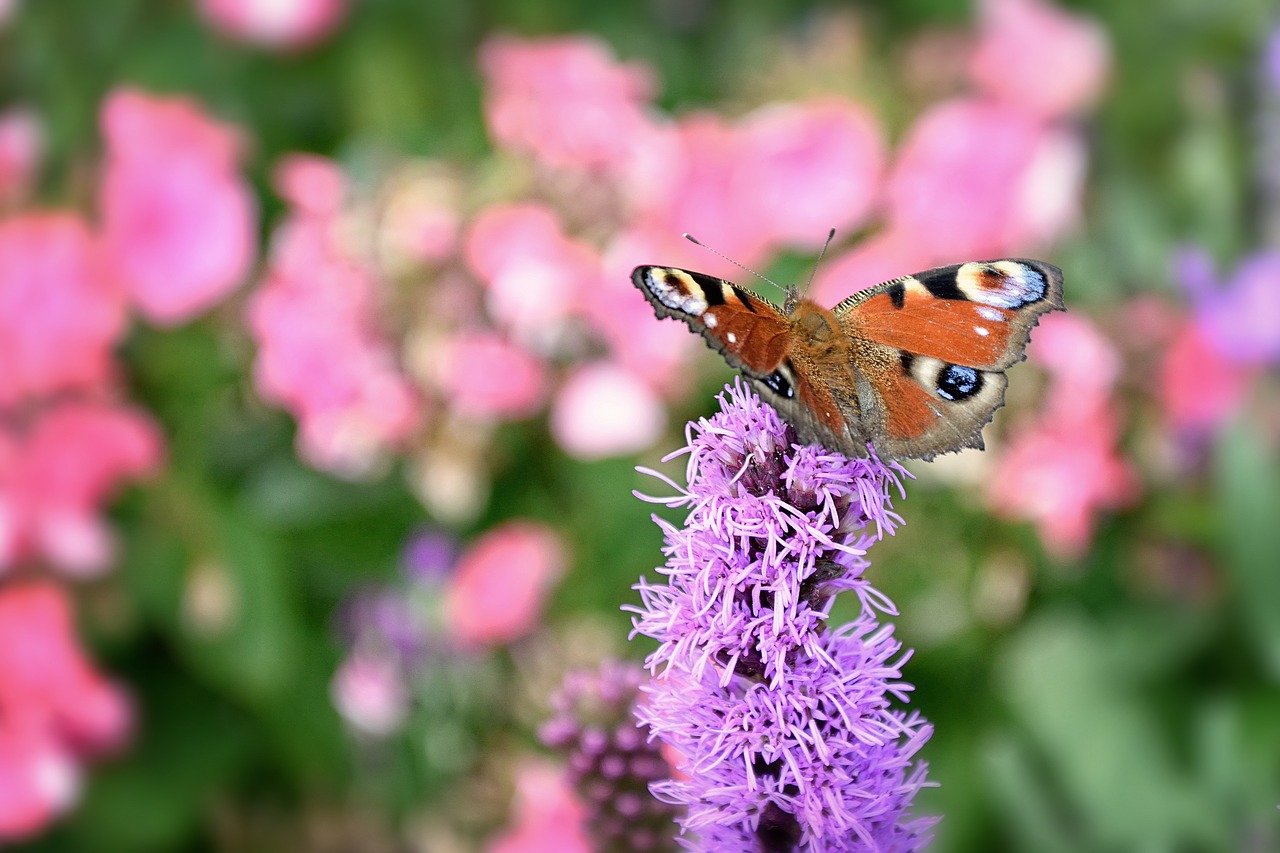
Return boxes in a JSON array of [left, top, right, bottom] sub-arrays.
[[0, 402, 163, 575]]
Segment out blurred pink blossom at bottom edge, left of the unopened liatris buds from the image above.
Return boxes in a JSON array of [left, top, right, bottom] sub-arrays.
[[485, 761, 595, 853]]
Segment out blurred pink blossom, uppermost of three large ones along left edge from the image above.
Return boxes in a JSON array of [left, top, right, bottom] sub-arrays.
[[0, 213, 125, 405]]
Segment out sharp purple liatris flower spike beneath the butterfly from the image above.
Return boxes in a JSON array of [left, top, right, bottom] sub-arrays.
[[630, 383, 933, 853]]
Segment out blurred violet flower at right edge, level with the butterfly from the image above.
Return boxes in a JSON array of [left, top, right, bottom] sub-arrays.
[[1175, 248, 1280, 365]]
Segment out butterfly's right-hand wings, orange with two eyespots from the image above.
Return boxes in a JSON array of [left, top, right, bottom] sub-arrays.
[[835, 259, 1062, 459]]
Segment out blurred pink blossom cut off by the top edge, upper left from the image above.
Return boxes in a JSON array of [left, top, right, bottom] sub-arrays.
[[200, 0, 347, 50]]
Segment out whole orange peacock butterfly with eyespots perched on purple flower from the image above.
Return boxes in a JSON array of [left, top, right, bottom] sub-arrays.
[[631, 259, 1064, 460]]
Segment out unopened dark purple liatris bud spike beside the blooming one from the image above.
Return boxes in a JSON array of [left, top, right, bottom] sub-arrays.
[[541, 662, 677, 853]]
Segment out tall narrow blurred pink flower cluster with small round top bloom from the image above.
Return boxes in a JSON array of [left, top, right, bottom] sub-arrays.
[[250, 154, 421, 475]]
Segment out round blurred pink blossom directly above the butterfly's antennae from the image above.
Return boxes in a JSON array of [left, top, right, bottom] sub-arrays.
[[741, 97, 884, 250]]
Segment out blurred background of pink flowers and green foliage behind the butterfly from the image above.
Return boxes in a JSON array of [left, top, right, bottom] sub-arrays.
[[0, 0, 1280, 853]]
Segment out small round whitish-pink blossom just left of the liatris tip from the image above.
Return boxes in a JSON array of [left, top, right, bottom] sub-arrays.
[[550, 362, 667, 460]]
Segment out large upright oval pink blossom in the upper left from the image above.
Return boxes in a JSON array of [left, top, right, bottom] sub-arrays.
[[100, 90, 256, 325]]
